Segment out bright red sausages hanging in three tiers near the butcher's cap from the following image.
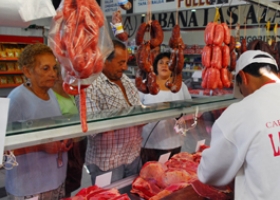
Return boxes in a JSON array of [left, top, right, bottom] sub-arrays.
[[201, 22, 232, 90]]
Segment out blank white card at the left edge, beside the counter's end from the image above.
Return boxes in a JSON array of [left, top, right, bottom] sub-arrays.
[[0, 98, 10, 165]]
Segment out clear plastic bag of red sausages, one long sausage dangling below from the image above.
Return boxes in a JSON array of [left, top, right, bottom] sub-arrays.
[[48, 0, 114, 132]]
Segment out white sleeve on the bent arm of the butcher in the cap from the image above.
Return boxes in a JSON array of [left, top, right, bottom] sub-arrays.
[[197, 123, 243, 186]]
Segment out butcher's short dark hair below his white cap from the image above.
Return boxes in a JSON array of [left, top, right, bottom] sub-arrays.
[[236, 63, 278, 84]]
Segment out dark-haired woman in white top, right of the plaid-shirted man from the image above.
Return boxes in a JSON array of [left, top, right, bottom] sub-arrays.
[[140, 53, 191, 162]]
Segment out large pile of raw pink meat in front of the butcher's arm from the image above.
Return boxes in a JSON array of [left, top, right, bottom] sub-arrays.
[[131, 151, 230, 200]]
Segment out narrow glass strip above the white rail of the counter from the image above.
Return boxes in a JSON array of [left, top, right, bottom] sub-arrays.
[[7, 95, 233, 136]]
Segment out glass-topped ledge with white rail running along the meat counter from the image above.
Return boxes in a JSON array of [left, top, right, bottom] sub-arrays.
[[5, 95, 239, 150]]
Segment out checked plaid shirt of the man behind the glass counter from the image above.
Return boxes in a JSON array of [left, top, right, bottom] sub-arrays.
[[77, 73, 142, 171]]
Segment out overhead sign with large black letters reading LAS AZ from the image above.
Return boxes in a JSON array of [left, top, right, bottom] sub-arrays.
[[108, 3, 280, 45]]
